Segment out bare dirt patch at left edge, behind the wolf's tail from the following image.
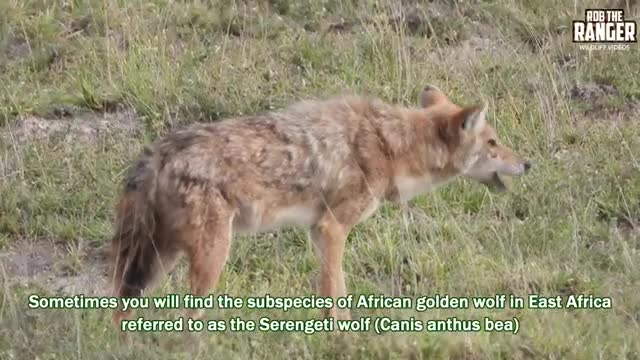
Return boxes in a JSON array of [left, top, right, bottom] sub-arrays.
[[0, 240, 109, 295]]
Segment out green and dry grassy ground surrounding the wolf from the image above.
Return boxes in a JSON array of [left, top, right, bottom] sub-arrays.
[[0, 0, 640, 359]]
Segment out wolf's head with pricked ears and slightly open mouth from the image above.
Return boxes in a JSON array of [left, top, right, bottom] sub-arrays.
[[421, 86, 531, 191]]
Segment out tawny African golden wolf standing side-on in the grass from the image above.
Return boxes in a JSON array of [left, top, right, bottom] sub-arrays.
[[112, 86, 531, 323]]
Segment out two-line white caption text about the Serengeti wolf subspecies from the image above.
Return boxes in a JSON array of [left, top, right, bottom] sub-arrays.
[[28, 294, 613, 335]]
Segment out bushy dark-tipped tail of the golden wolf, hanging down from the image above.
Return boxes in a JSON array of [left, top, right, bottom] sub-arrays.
[[111, 152, 163, 297]]
